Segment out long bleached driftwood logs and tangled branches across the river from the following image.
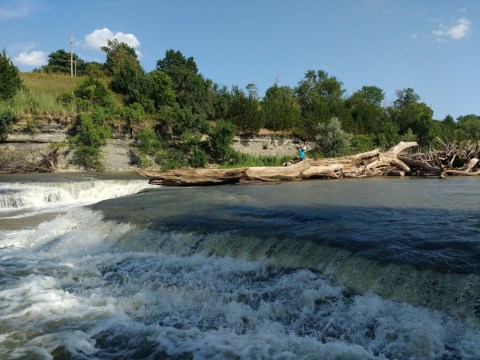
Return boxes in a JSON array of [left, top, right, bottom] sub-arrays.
[[140, 142, 480, 186]]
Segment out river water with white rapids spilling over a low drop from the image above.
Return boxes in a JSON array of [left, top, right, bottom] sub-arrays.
[[0, 174, 480, 359]]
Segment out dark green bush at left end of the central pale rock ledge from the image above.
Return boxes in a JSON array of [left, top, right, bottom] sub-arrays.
[[209, 120, 235, 162]]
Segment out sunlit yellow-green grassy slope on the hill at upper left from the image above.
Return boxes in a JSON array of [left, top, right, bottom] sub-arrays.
[[0, 73, 121, 119]]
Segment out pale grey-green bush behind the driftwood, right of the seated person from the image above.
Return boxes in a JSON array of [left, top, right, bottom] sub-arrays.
[[316, 117, 353, 157]]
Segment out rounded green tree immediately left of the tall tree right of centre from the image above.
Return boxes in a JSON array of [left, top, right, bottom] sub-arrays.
[[263, 84, 301, 131]]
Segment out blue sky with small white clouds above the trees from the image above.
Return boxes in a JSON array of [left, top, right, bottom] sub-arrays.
[[0, 0, 480, 119]]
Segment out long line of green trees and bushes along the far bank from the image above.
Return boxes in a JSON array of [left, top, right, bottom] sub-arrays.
[[0, 40, 480, 168]]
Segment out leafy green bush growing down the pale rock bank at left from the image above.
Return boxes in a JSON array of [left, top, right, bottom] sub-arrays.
[[71, 109, 111, 171]]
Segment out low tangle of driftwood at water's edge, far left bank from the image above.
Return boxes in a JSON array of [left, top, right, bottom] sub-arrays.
[[0, 148, 60, 174]]
